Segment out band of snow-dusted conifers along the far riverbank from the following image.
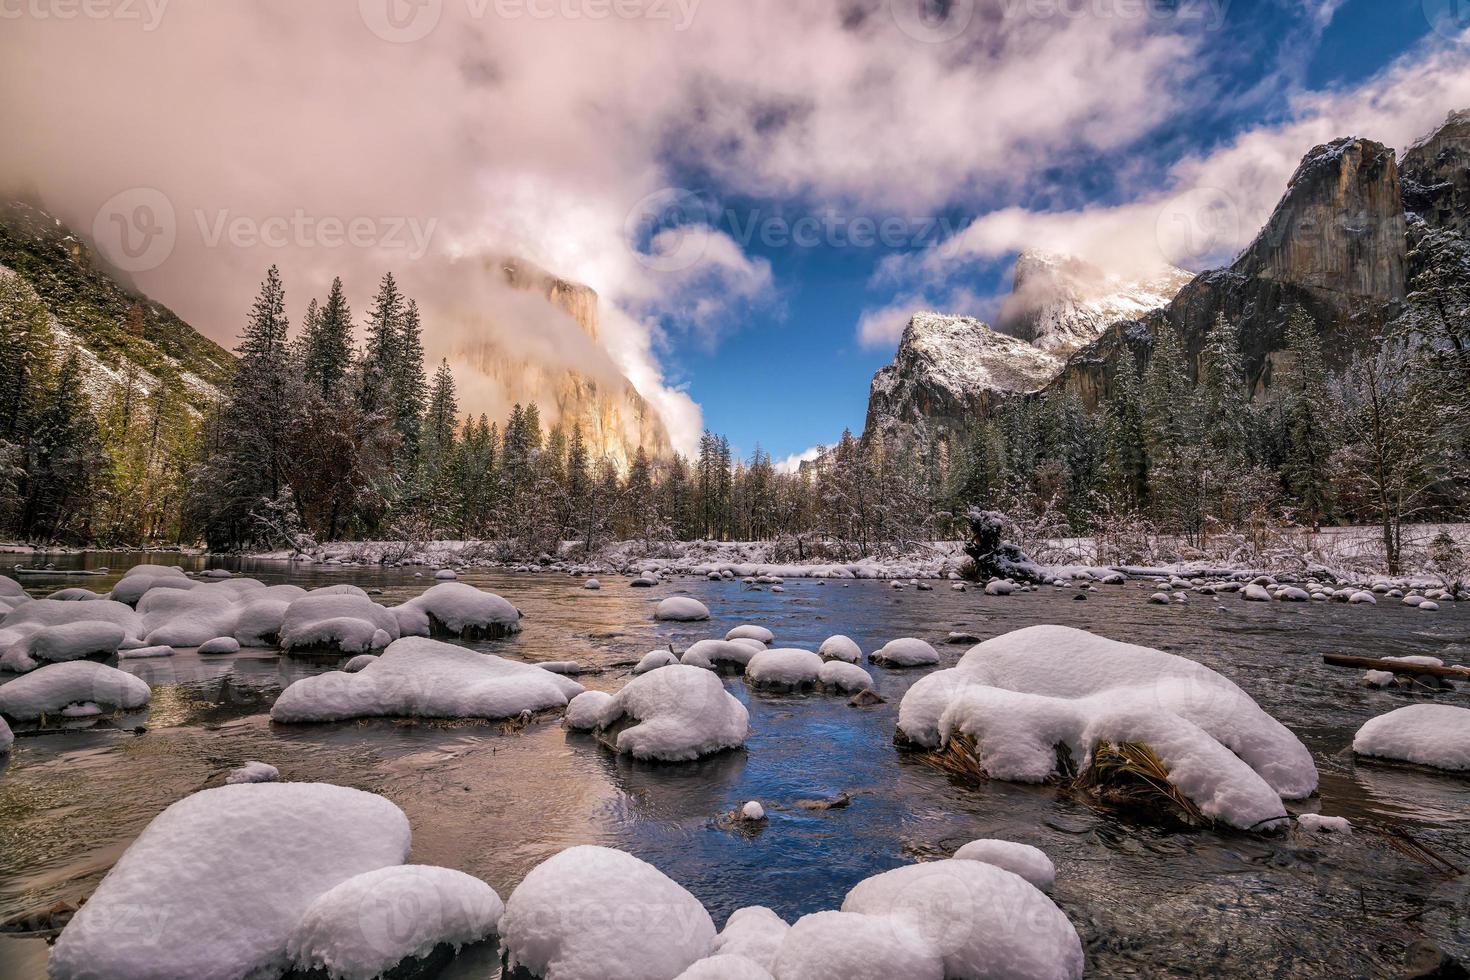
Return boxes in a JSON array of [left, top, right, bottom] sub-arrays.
[[0, 253, 1470, 567]]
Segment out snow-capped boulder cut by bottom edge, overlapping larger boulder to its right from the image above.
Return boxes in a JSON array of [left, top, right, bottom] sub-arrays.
[[773, 911, 940, 980]]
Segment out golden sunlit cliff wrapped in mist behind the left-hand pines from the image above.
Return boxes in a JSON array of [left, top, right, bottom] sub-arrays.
[[454, 260, 673, 470]]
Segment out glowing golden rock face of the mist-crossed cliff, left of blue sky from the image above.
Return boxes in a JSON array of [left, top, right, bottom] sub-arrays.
[[457, 260, 673, 470]]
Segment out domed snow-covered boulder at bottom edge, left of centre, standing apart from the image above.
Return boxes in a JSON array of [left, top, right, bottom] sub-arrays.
[[500, 846, 714, 980]]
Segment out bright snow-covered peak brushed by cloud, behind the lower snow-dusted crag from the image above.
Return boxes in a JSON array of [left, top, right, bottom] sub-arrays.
[[995, 250, 1192, 357]]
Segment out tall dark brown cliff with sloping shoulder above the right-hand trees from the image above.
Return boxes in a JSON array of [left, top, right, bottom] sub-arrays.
[[1054, 140, 1410, 406]]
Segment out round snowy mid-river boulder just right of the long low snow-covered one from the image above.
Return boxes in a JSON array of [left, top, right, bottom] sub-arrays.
[[598, 664, 746, 763]]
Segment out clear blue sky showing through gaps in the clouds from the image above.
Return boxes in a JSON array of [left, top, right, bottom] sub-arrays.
[[664, 0, 1451, 460]]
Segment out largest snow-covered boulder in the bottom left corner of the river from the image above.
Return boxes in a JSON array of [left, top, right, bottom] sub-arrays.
[[49, 783, 410, 980]]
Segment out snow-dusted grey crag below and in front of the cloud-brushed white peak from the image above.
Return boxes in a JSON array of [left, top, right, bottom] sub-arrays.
[[864, 313, 1061, 444]]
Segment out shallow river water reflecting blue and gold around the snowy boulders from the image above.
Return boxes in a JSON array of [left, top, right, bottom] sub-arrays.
[[0, 554, 1470, 980]]
